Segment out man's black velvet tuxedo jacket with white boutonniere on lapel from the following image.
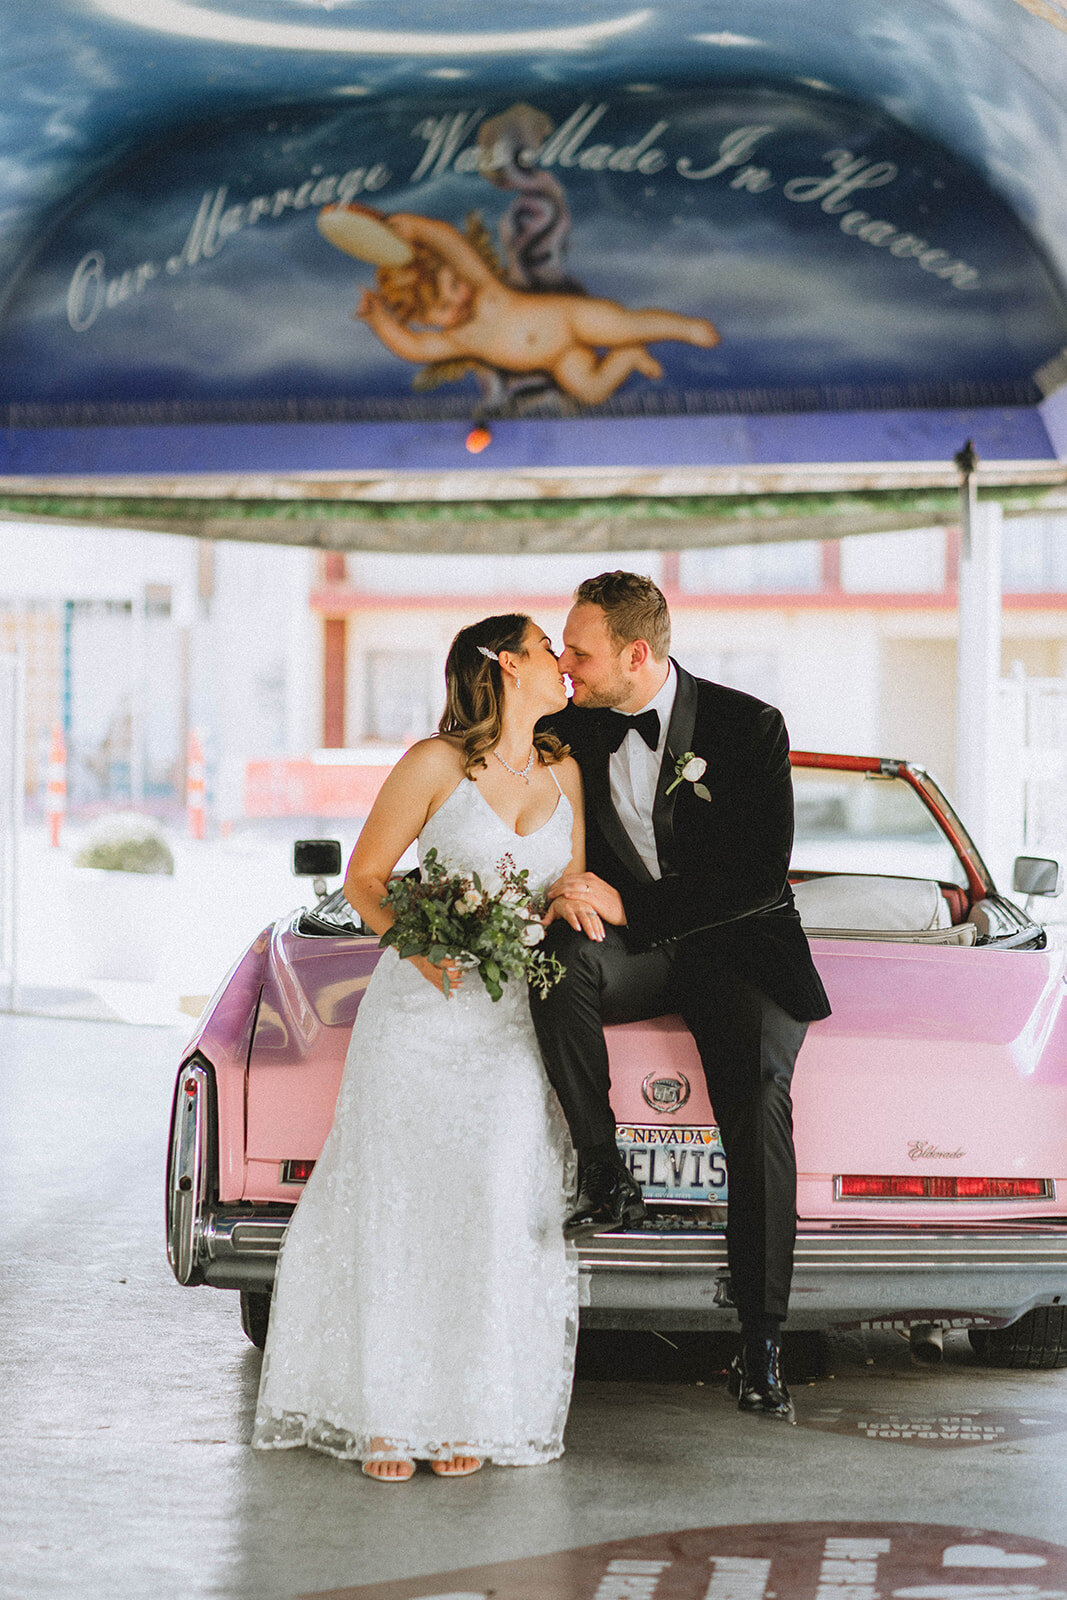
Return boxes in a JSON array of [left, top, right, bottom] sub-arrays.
[[544, 662, 830, 1022]]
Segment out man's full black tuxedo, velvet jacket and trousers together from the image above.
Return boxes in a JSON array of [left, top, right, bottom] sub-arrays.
[[531, 662, 830, 1322]]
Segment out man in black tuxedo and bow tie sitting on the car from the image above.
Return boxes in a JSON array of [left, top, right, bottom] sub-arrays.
[[533, 573, 830, 1419]]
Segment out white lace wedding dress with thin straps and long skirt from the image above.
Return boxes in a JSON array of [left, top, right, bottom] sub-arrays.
[[253, 774, 577, 1466]]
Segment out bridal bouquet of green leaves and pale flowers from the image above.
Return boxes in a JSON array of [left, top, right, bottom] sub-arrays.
[[378, 850, 563, 1000]]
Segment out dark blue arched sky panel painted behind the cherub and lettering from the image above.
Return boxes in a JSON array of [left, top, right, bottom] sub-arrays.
[[0, 85, 1067, 419]]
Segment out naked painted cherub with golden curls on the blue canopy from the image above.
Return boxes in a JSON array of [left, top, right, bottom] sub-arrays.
[[323, 211, 718, 405]]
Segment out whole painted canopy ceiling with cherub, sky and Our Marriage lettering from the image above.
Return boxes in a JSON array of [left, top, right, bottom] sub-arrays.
[[0, 0, 1067, 524]]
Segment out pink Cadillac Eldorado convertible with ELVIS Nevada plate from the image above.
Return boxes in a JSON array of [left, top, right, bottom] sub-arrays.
[[166, 752, 1067, 1366]]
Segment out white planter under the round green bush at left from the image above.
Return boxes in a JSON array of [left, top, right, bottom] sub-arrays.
[[67, 867, 174, 984]]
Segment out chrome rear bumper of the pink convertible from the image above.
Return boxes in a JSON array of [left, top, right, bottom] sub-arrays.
[[189, 1205, 1067, 1330]]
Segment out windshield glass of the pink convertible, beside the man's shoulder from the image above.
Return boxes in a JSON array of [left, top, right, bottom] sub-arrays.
[[790, 766, 966, 886]]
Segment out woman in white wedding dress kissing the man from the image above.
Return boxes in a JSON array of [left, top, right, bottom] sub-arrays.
[[253, 614, 603, 1482]]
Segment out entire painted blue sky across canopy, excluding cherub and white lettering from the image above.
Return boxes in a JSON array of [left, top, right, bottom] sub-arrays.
[[0, 0, 1067, 435]]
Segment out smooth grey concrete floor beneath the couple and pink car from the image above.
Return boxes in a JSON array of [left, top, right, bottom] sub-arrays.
[[0, 1016, 1067, 1600]]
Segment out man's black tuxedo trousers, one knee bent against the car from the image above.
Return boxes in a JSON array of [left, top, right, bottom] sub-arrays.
[[531, 922, 808, 1323]]
